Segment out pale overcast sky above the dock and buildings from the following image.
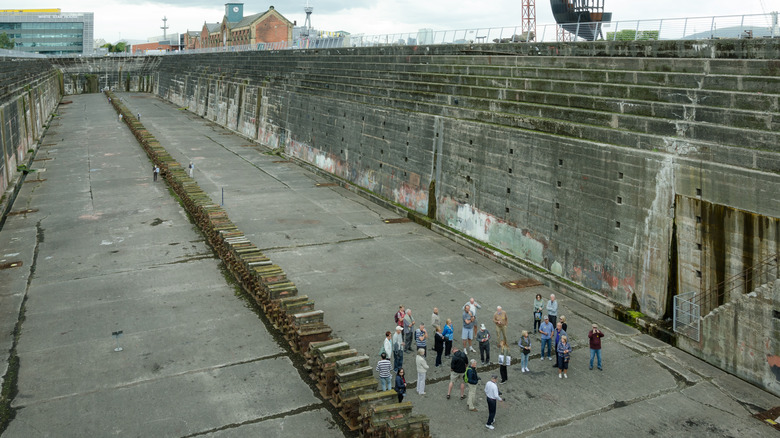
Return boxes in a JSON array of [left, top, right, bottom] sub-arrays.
[[18, 0, 780, 42]]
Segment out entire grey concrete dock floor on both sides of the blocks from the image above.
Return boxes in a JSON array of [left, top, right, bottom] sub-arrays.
[[0, 93, 780, 438]]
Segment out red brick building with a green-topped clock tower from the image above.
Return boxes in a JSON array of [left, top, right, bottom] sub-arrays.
[[185, 3, 295, 49]]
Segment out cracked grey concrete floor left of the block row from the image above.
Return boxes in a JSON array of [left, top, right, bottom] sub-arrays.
[[0, 95, 343, 437]]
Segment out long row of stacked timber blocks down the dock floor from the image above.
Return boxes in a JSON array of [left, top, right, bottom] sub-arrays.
[[106, 92, 430, 438]]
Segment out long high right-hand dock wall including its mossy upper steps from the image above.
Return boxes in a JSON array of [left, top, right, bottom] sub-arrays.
[[154, 40, 780, 319]]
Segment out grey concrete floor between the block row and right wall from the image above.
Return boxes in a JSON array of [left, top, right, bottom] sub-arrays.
[[114, 94, 780, 437]]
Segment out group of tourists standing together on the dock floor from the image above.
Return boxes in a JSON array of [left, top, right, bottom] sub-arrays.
[[376, 294, 604, 429]]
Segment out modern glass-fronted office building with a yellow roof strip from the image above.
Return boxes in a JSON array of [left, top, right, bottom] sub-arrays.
[[0, 9, 95, 55]]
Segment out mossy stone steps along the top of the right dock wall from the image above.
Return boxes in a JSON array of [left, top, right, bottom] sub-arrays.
[[155, 44, 780, 171]]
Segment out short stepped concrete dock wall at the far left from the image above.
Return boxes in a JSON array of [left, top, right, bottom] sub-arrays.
[[0, 58, 61, 193]]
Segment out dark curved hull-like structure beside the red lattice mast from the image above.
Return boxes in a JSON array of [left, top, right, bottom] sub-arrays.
[[550, 0, 612, 41]]
